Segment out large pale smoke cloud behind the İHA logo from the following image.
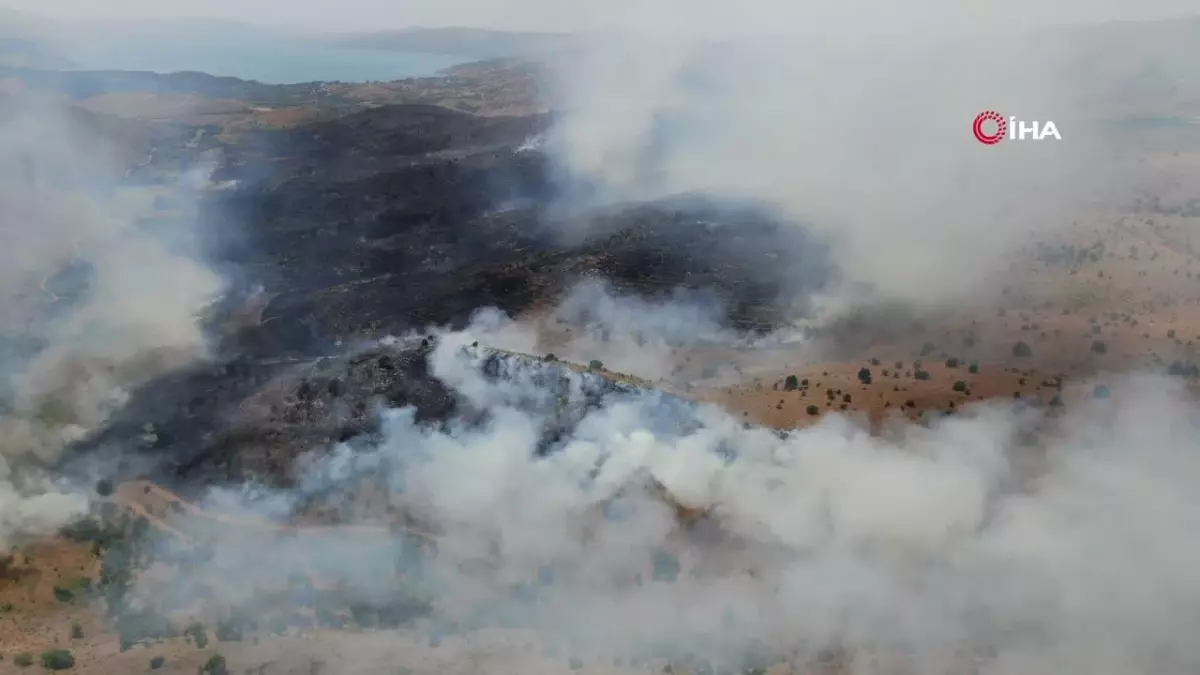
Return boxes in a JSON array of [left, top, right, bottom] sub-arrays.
[[545, 2, 1120, 304]]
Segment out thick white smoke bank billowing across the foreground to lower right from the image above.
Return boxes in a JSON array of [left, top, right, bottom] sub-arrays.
[[147, 321, 1200, 675]]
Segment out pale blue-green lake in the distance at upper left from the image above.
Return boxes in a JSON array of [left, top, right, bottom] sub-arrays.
[[63, 36, 476, 84]]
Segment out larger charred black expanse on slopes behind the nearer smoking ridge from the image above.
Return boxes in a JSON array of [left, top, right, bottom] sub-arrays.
[[205, 106, 830, 354]]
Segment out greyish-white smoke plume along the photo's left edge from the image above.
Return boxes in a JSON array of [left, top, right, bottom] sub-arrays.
[[0, 97, 222, 545]]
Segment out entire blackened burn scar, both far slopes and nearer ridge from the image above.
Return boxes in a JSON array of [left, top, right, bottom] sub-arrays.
[[60, 99, 830, 486]]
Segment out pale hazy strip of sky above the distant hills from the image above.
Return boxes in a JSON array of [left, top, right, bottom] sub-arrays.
[[7, 0, 1200, 35]]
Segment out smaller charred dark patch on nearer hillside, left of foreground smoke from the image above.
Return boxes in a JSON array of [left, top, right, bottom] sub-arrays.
[[69, 340, 457, 485]]
